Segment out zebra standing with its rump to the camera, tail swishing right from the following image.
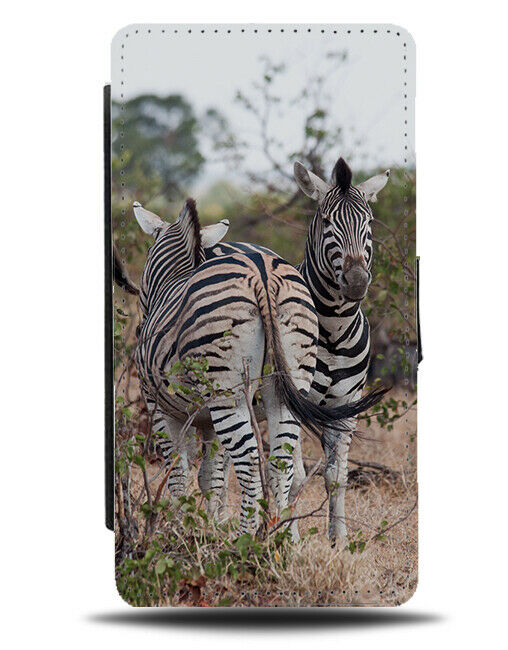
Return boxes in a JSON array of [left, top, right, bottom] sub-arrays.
[[133, 199, 381, 539]]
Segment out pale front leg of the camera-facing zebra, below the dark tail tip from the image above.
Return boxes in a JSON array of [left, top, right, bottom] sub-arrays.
[[324, 418, 356, 544]]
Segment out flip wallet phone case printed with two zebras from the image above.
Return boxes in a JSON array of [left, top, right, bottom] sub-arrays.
[[105, 25, 421, 607]]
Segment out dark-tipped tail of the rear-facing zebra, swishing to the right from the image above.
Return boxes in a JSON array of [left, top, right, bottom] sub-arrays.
[[254, 274, 390, 440]]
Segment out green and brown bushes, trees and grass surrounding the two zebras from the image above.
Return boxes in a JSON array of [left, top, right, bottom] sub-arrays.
[[112, 52, 417, 606]]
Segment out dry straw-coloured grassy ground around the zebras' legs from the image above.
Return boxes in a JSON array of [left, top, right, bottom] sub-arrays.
[[124, 391, 417, 606]]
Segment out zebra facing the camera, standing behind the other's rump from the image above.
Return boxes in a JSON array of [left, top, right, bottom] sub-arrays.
[[202, 157, 390, 543]]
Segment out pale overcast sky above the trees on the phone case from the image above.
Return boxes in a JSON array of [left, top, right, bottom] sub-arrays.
[[112, 25, 414, 187]]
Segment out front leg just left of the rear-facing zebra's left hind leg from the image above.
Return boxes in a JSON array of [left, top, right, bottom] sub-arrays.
[[198, 429, 231, 521]]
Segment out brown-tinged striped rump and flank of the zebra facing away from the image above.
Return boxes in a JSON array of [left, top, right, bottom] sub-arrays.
[[136, 251, 318, 423]]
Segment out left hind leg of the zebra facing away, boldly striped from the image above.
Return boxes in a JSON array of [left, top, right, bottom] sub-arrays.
[[210, 402, 262, 534]]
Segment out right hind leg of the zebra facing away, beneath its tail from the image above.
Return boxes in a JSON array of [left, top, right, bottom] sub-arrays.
[[261, 378, 305, 542]]
